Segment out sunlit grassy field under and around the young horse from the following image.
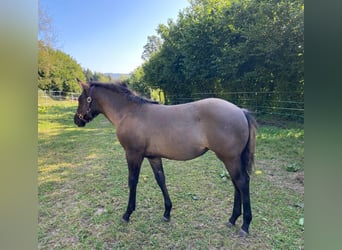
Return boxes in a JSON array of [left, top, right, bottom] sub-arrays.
[[38, 103, 304, 249]]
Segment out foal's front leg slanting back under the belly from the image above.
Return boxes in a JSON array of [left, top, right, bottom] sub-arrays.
[[148, 158, 172, 221]]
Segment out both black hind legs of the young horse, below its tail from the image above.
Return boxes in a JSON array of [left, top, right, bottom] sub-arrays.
[[225, 159, 252, 236]]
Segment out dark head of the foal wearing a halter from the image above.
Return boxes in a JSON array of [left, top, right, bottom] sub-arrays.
[[74, 79, 99, 127]]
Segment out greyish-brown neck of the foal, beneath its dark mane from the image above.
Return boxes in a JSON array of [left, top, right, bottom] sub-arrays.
[[99, 91, 133, 127]]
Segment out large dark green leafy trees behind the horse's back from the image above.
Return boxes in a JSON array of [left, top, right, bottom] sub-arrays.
[[143, 0, 304, 104]]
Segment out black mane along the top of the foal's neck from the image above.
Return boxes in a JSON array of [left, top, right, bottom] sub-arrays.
[[90, 81, 159, 104]]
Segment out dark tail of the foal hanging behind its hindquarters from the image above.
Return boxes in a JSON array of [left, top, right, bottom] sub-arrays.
[[241, 109, 258, 174]]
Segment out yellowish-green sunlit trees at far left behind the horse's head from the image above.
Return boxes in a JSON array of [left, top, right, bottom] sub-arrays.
[[38, 41, 85, 92]]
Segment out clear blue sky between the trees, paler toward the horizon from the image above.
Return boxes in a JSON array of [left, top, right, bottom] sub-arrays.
[[41, 0, 190, 74]]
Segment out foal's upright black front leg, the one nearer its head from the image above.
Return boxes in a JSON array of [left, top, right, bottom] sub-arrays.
[[122, 152, 143, 222]]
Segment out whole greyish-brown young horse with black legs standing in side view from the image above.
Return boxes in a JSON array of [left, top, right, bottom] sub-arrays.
[[74, 80, 256, 236]]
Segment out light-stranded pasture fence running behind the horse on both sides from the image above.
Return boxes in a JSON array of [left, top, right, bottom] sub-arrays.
[[38, 90, 304, 123]]
